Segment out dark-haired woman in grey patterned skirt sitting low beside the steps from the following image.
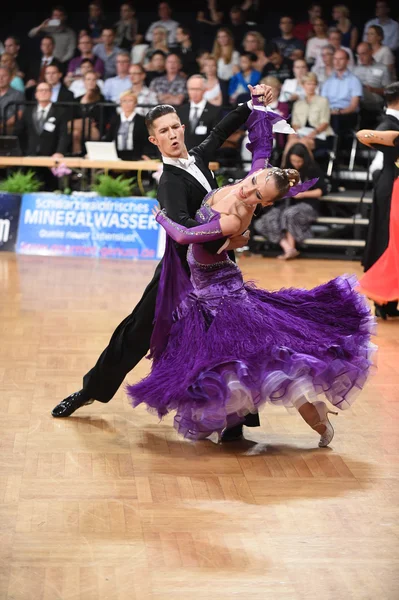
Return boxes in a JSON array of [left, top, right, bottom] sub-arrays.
[[254, 143, 327, 260]]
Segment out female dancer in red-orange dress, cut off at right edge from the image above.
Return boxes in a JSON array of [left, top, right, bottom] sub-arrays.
[[356, 129, 399, 312]]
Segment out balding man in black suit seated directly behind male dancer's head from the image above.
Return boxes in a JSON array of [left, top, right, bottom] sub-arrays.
[[177, 75, 222, 152]]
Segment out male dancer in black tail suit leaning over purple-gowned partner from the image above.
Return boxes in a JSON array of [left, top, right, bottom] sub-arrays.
[[52, 85, 272, 441]]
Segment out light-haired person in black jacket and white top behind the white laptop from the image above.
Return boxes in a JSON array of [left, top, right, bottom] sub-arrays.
[[105, 90, 153, 160]]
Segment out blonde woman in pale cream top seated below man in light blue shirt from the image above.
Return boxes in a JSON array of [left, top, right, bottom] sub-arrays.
[[282, 73, 334, 161]]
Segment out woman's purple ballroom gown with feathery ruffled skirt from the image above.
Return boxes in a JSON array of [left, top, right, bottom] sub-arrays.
[[127, 103, 375, 440]]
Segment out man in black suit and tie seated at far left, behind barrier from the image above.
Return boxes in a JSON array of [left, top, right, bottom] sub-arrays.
[[15, 82, 68, 158]]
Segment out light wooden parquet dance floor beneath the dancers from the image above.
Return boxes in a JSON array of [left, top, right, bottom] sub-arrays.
[[0, 252, 399, 600]]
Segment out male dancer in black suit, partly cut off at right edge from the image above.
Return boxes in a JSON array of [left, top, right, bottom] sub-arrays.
[[362, 81, 399, 318]]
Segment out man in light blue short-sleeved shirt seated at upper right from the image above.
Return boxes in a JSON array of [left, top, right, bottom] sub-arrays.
[[321, 50, 363, 135]]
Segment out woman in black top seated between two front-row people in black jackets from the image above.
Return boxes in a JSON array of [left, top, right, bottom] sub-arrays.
[[68, 70, 105, 154]]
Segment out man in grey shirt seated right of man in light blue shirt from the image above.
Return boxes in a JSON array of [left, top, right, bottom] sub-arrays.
[[353, 42, 391, 116]]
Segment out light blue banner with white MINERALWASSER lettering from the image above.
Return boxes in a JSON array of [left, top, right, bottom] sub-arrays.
[[17, 193, 165, 260]]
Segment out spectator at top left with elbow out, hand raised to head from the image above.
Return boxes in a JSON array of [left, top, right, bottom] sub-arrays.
[[28, 6, 76, 64]]
